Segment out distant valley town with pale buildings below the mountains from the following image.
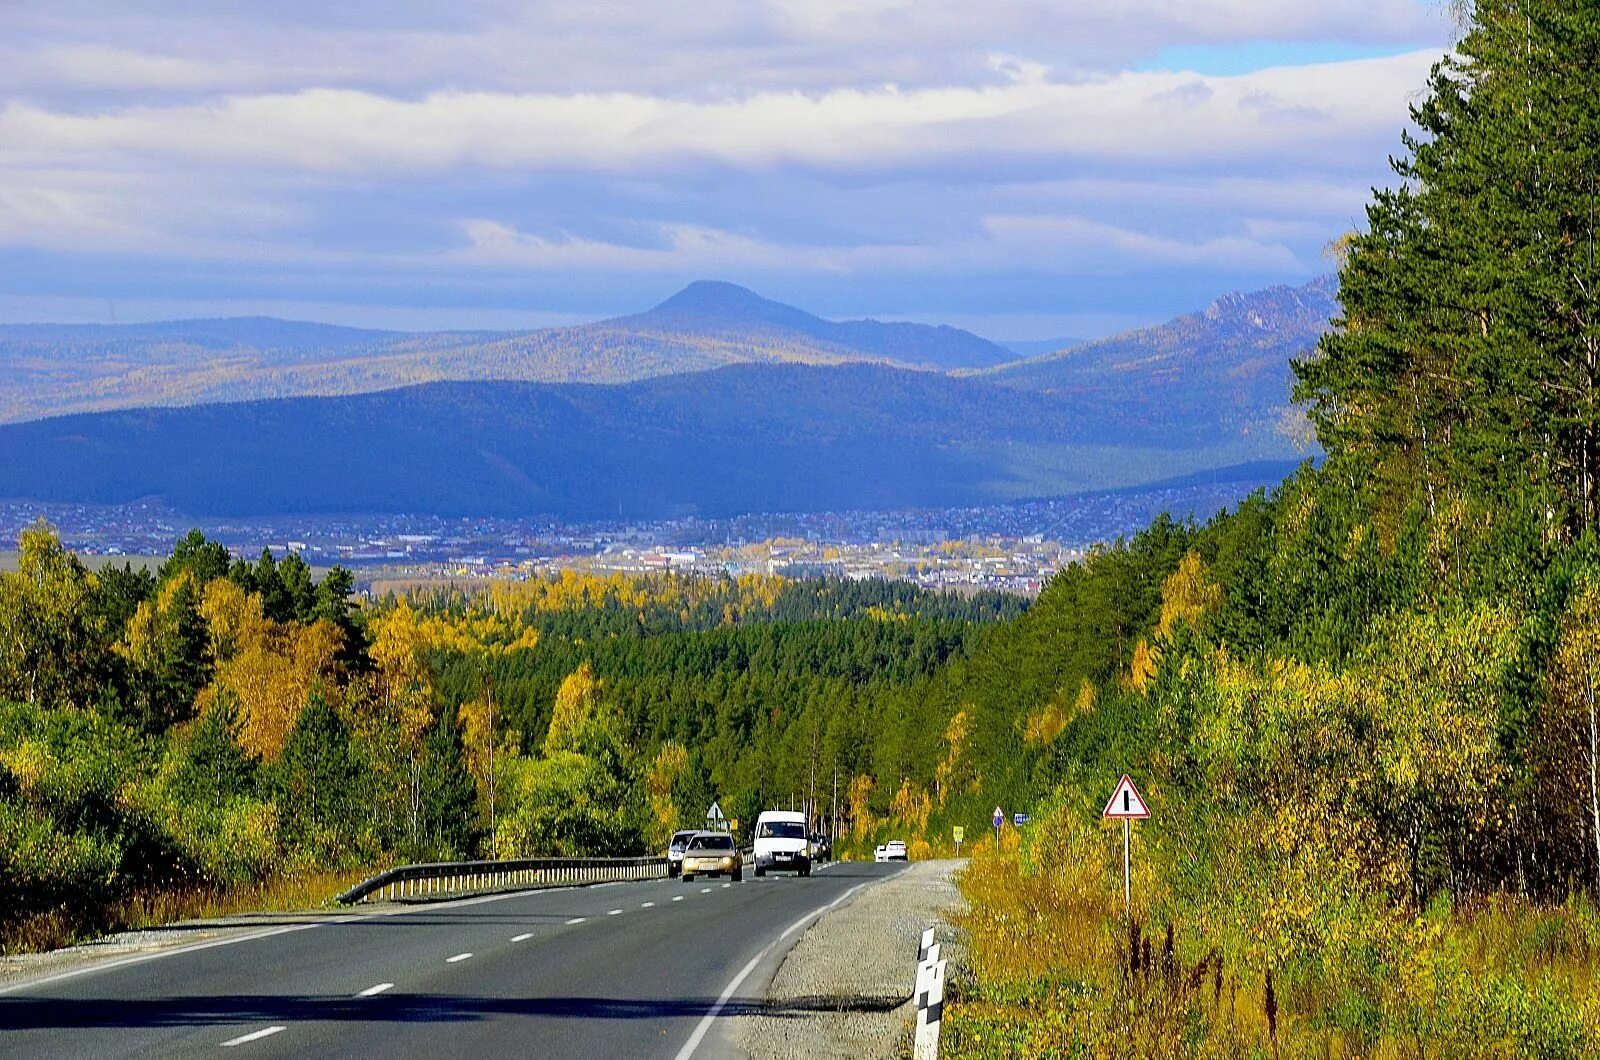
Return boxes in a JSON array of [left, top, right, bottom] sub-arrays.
[[0, 482, 1258, 594]]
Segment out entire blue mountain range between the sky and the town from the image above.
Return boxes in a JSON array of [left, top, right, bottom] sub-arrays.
[[0, 280, 1336, 519]]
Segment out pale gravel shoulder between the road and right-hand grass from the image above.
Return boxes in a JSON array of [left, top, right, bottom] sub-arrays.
[[733, 860, 965, 1060]]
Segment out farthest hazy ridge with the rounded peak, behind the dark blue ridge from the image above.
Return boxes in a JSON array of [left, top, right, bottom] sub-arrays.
[[0, 280, 1016, 423]]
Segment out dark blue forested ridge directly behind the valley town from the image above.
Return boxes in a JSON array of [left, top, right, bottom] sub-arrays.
[[0, 365, 1296, 520]]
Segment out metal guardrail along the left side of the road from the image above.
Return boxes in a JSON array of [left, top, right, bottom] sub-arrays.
[[334, 858, 667, 905]]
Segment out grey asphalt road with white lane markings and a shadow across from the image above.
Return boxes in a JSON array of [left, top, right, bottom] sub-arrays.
[[0, 863, 910, 1060]]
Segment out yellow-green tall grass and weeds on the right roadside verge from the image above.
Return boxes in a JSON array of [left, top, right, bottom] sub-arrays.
[[942, 815, 1600, 1060]]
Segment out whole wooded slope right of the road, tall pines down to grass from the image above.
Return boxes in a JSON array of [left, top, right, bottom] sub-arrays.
[[918, 0, 1600, 1057]]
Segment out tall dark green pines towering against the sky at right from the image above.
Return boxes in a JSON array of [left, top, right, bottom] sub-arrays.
[[1296, 0, 1600, 533]]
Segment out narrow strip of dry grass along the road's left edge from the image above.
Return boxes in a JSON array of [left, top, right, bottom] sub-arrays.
[[0, 869, 371, 954]]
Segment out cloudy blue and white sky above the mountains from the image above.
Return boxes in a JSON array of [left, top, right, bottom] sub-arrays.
[[0, 0, 1454, 341]]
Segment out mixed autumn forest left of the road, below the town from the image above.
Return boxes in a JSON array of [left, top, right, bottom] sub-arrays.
[[0, 544, 1022, 950]]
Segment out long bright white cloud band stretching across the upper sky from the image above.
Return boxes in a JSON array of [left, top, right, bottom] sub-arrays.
[[0, 53, 1435, 171]]
